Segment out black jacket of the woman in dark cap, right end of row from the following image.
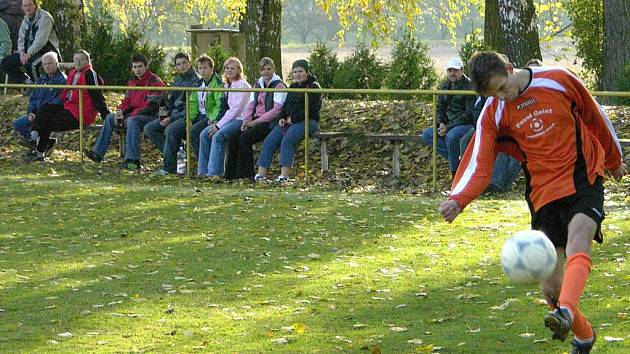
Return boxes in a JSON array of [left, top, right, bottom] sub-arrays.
[[280, 75, 322, 123]]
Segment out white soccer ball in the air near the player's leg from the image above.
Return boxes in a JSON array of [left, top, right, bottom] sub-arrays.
[[501, 230, 558, 284]]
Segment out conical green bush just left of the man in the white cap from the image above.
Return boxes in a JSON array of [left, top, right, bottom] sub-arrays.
[[385, 32, 437, 99]]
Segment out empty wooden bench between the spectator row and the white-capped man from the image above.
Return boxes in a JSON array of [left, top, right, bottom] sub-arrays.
[[312, 131, 421, 178]]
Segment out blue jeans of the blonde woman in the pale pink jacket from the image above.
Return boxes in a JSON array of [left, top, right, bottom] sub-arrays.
[[197, 119, 243, 176]]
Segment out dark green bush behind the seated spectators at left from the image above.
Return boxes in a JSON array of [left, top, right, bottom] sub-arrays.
[[81, 8, 167, 85]]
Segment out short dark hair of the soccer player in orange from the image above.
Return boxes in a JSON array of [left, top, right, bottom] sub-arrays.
[[468, 51, 510, 95]]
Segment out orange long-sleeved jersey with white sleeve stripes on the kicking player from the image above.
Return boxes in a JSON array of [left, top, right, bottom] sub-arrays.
[[449, 67, 622, 211]]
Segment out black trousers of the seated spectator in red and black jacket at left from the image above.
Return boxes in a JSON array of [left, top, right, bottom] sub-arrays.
[[31, 104, 79, 153]]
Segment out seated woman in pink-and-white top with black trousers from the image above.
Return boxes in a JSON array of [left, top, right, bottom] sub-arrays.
[[235, 57, 287, 179]]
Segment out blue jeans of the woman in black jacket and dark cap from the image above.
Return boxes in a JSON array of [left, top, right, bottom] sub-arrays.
[[257, 120, 319, 168]]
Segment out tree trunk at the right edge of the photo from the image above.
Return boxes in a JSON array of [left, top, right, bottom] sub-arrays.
[[600, 0, 630, 91]]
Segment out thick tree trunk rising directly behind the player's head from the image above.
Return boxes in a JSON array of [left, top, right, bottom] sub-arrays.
[[484, 0, 544, 67]]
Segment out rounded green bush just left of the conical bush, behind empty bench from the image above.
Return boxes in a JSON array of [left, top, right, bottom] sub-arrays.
[[333, 45, 387, 98]]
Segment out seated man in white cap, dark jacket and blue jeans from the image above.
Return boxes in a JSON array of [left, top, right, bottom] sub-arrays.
[[422, 58, 475, 176]]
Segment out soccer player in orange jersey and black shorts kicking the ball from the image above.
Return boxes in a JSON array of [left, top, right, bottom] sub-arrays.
[[439, 52, 626, 353]]
